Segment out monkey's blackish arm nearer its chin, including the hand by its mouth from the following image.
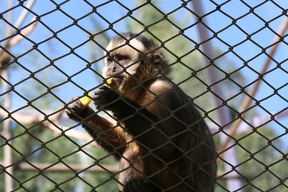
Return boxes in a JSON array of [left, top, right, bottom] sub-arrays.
[[93, 87, 175, 161]]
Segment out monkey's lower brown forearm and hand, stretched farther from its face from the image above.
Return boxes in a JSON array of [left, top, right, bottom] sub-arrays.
[[66, 99, 126, 159]]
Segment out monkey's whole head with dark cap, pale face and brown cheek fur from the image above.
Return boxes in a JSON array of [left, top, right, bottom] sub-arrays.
[[103, 33, 171, 93]]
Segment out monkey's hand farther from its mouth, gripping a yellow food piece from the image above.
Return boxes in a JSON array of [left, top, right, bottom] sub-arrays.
[[65, 97, 94, 121]]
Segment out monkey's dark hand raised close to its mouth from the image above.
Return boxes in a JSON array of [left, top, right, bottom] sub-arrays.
[[93, 86, 121, 111]]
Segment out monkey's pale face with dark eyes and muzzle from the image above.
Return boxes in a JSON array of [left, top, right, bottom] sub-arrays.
[[102, 39, 144, 88]]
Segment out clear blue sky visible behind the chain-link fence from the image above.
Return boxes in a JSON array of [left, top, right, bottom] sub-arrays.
[[0, 0, 288, 141]]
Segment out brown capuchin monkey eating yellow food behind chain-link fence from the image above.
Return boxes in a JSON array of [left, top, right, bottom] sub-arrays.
[[66, 33, 217, 192]]
